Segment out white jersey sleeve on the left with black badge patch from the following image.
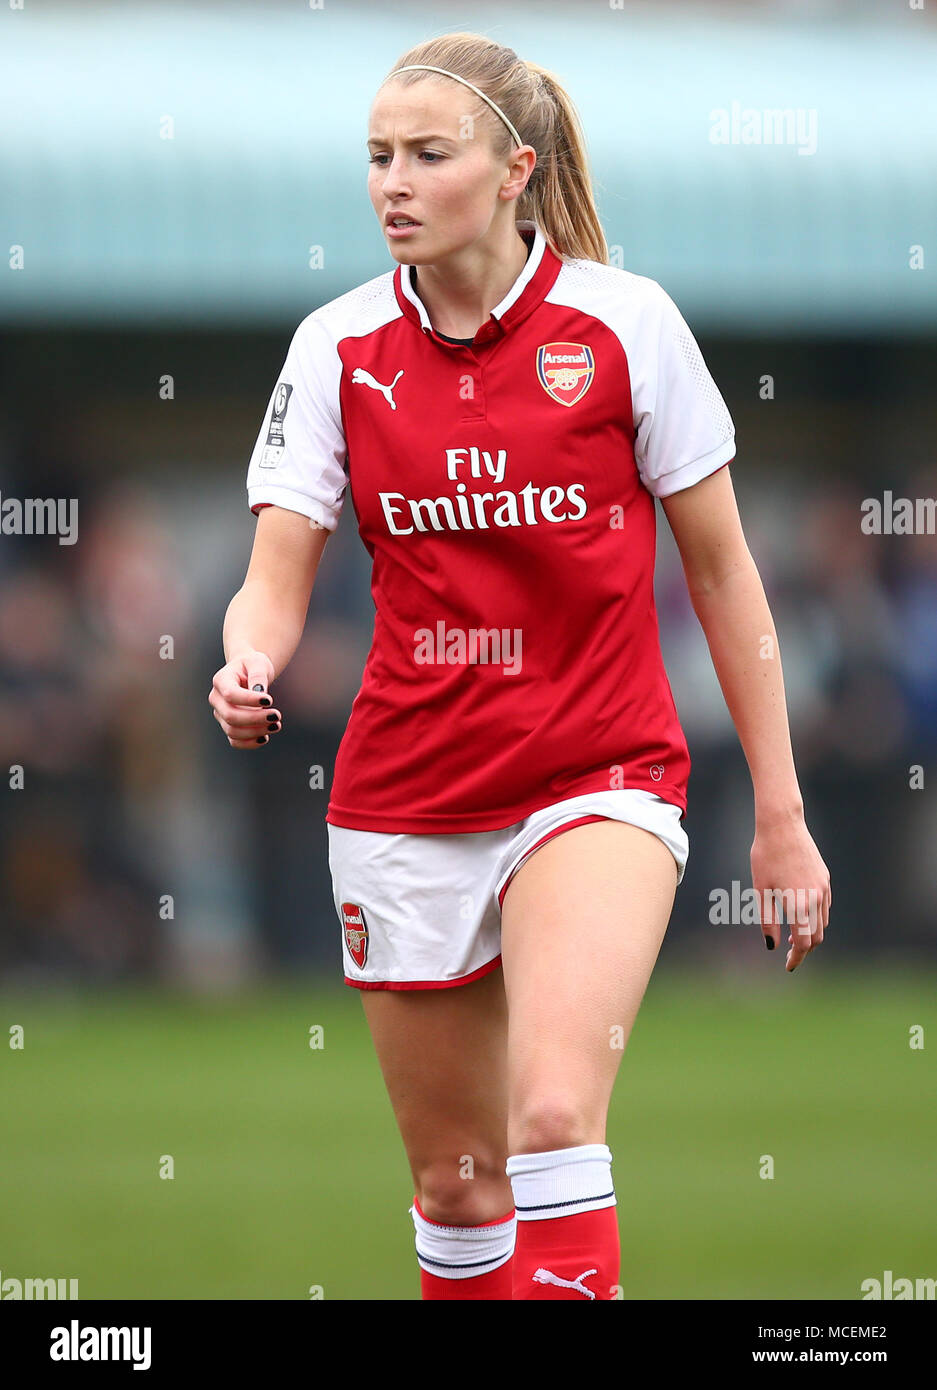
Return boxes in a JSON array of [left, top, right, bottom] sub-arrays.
[[247, 314, 348, 531]]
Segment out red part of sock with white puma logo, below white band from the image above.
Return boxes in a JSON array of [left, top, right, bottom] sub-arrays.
[[512, 1207, 621, 1302]]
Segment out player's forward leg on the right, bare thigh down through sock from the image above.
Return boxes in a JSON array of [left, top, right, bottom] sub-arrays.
[[502, 820, 677, 1300]]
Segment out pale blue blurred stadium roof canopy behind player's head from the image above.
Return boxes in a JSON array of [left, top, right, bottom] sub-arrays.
[[0, 3, 937, 332]]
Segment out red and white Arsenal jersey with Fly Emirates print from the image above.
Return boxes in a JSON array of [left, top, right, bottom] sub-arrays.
[[247, 222, 735, 834]]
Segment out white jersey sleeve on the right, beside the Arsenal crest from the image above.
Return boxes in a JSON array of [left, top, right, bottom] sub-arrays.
[[631, 281, 735, 498]]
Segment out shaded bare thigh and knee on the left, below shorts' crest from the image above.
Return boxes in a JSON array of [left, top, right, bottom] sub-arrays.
[[361, 967, 513, 1226]]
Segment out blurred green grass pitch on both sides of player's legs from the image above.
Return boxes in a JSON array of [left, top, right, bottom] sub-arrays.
[[0, 960, 937, 1300]]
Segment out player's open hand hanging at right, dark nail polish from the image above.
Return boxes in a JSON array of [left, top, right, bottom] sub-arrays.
[[752, 815, 833, 972]]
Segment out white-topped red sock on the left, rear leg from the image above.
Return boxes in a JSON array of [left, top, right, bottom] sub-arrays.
[[410, 1197, 517, 1301]]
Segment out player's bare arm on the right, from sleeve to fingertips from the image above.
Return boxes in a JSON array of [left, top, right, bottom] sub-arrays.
[[660, 467, 831, 970]]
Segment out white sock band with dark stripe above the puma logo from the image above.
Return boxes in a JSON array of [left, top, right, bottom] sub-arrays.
[[505, 1144, 617, 1220]]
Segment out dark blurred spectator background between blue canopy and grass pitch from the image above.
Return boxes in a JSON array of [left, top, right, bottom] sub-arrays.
[[0, 326, 937, 981]]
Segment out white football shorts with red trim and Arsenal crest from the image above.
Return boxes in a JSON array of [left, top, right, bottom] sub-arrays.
[[327, 788, 690, 990]]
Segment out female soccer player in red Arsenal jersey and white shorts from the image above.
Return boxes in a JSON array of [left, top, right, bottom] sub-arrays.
[[209, 33, 830, 1300]]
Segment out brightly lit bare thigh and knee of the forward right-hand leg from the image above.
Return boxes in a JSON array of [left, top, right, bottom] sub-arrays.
[[502, 820, 677, 1154]]
